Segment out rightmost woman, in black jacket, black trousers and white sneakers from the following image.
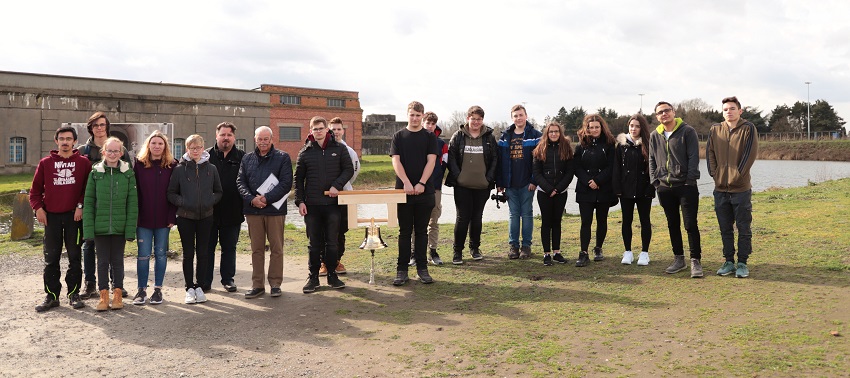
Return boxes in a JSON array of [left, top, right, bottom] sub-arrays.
[[612, 114, 655, 265]]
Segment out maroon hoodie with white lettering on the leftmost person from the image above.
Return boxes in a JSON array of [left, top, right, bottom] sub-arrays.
[[30, 149, 91, 213]]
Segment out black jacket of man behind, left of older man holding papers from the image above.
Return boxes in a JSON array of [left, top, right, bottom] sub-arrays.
[[207, 144, 245, 226]]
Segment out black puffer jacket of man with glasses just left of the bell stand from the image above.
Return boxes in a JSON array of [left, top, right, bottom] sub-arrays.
[[295, 132, 354, 206]]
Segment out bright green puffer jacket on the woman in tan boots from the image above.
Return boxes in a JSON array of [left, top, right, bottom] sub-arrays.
[[83, 160, 139, 239]]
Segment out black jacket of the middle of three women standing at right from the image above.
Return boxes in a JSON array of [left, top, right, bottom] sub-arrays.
[[573, 139, 617, 204]]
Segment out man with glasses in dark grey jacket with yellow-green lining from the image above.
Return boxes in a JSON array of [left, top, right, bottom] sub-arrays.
[[649, 101, 703, 278]]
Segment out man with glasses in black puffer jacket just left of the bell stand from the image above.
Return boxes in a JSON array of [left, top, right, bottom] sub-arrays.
[[295, 117, 354, 294]]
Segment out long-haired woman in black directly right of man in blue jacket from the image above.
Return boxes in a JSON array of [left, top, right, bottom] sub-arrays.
[[532, 122, 575, 266]]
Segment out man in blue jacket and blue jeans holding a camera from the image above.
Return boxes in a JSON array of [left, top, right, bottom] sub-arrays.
[[496, 105, 543, 259]]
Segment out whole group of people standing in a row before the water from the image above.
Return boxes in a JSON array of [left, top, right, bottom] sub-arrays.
[[30, 97, 757, 312]]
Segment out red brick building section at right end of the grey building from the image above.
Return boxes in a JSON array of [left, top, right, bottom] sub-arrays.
[[260, 84, 363, 162]]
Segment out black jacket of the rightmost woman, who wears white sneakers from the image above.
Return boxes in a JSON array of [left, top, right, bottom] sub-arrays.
[[612, 134, 655, 199]]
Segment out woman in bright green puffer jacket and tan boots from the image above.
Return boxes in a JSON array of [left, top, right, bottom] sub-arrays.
[[83, 137, 139, 311]]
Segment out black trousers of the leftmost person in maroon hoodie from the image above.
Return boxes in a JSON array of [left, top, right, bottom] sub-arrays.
[[43, 211, 82, 299]]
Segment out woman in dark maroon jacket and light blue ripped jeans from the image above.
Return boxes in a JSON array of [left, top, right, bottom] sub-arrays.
[[133, 131, 177, 306]]
